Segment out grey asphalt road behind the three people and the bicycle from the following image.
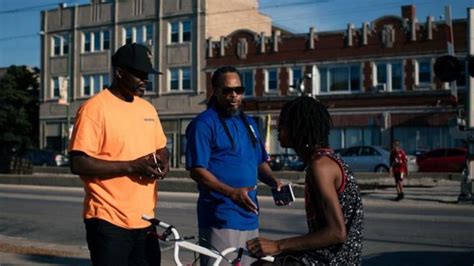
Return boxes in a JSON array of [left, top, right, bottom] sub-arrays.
[[0, 185, 474, 265]]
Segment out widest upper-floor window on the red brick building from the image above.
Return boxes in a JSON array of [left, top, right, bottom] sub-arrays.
[[319, 65, 361, 93]]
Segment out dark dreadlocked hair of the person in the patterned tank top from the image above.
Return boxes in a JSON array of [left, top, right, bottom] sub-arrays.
[[279, 96, 332, 152]]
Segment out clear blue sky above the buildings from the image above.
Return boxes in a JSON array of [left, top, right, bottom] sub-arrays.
[[0, 0, 474, 67]]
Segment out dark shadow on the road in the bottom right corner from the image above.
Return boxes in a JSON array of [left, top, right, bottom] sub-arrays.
[[362, 250, 474, 266]]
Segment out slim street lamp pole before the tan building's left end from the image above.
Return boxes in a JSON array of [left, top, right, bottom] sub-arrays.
[[39, 31, 74, 154]]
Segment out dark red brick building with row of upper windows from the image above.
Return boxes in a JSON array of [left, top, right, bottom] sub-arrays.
[[205, 6, 468, 156]]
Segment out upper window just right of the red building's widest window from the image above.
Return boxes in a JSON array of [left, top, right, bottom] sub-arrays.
[[375, 62, 403, 91]]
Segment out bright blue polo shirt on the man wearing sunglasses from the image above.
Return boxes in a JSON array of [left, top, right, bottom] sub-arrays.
[[186, 107, 268, 230]]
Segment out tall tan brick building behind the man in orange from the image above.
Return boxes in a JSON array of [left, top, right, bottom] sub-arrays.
[[39, 0, 271, 166]]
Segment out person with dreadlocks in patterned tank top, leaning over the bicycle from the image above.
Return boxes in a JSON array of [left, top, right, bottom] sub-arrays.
[[247, 96, 363, 265]]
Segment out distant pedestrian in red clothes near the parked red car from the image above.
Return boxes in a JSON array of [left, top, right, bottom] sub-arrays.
[[390, 140, 408, 201]]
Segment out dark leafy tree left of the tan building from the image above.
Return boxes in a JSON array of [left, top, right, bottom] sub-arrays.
[[0, 66, 39, 155]]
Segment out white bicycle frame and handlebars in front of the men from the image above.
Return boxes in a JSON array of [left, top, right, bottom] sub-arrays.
[[142, 215, 274, 266]]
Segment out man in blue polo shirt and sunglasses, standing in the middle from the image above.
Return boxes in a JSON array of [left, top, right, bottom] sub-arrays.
[[186, 66, 283, 265]]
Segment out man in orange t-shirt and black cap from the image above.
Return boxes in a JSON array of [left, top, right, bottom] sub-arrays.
[[69, 43, 169, 266]]
